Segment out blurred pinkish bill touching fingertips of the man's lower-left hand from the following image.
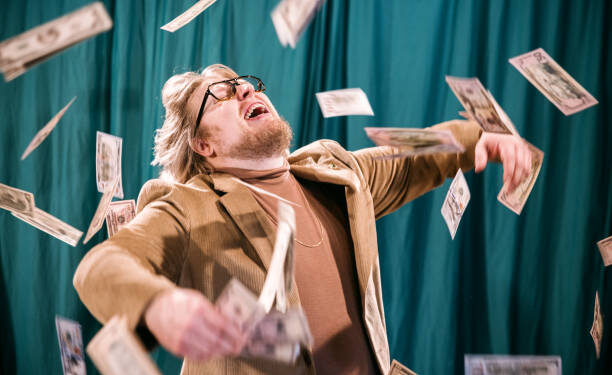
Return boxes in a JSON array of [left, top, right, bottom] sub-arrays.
[[215, 278, 266, 332]]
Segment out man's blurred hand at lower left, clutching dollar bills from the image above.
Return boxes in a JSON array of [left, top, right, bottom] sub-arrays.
[[144, 288, 246, 361]]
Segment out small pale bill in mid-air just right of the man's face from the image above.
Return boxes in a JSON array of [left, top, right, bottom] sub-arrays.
[[315, 88, 374, 118]]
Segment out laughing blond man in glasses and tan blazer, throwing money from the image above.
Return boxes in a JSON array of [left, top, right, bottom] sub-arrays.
[[74, 64, 530, 374]]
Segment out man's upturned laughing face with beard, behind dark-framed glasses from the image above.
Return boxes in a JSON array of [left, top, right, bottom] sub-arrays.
[[192, 73, 291, 159]]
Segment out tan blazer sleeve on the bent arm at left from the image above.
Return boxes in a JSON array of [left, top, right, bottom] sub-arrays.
[[73, 180, 190, 329]]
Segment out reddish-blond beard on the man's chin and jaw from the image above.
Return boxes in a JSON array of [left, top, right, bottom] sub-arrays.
[[220, 118, 293, 160]]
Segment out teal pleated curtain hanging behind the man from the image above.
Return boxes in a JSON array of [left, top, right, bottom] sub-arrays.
[[0, 0, 612, 375]]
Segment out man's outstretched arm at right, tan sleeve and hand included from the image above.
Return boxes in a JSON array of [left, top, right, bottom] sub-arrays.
[[354, 120, 530, 218]]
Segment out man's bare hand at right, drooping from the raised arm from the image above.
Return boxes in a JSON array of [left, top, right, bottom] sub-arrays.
[[474, 133, 531, 192]]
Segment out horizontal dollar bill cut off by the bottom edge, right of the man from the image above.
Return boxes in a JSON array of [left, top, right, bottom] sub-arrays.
[[464, 354, 562, 375]]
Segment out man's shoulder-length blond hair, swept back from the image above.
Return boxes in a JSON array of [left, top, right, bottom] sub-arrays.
[[151, 64, 237, 183]]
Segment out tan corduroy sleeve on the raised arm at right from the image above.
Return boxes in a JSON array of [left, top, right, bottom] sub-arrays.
[[354, 120, 482, 219]]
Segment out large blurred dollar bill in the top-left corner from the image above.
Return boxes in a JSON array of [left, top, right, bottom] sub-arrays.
[[0, 2, 113, 81]]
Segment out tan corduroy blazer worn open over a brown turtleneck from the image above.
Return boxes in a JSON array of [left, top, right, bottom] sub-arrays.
[[74, 120, 481, 375]]
